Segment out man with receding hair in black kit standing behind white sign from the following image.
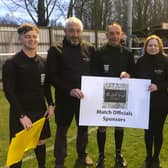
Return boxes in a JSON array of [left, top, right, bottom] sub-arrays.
[[91, 23, 135, 168]]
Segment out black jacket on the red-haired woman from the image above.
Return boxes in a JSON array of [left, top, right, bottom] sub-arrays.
[[136, 54, 168, 111]]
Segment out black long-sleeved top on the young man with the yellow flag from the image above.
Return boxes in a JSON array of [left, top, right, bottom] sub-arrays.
[[2, 51, 53, 120]]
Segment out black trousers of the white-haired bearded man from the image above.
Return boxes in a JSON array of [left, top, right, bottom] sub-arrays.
[[54, 96, 88, 165]]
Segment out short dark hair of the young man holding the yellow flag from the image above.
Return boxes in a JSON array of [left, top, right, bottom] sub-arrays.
[[17, 23, 39, 35]]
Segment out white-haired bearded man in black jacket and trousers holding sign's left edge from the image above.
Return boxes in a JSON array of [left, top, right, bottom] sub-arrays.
[[47, 17, 94, 168]]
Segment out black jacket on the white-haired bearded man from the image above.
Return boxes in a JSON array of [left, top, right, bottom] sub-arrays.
[[47, 38, 94, 95]]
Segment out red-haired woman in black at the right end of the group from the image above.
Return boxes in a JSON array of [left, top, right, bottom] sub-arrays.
[[136, 35, 168, 168]]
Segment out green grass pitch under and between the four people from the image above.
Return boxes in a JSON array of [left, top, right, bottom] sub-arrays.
[[0, 91, 168, 168]]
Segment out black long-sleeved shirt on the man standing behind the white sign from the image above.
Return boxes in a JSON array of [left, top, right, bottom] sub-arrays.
[[91, 44, 135, 77]]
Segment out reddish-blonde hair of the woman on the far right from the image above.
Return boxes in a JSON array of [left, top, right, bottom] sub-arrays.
[[144, 35, 164, 54]]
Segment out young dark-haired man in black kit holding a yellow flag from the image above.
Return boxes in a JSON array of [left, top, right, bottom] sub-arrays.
[[3, 24, 54, 168]]
